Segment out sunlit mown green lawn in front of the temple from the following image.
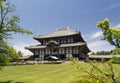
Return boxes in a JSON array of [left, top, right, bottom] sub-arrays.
[[0, 63, 120, 83]]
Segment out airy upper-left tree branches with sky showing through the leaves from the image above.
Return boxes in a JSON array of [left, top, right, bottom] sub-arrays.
[[0, 0, 32, 40]]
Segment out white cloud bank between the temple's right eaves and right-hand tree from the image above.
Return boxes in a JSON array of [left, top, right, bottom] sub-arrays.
[[86, 31, 114, 52]]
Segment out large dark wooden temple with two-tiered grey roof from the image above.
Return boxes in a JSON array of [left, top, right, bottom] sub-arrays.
[[25, 27, 90, 60]]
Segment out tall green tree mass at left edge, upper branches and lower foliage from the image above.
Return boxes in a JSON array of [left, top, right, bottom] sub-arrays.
[[0, 0, 32, 68]]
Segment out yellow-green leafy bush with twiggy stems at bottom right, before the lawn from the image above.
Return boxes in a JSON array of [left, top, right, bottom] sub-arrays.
[[73, 60, 120, 83]]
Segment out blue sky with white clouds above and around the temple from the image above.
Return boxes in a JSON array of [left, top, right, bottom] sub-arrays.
[[9, 0, 120, 55]]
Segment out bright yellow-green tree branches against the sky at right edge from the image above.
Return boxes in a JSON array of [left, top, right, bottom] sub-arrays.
[[97, 18, 120, 48]]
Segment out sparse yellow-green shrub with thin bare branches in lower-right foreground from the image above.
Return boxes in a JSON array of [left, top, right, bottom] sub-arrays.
[[71, 58, 120, 83]]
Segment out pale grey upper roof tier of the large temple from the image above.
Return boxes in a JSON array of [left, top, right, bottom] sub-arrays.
[[34, 27, 80, 39]]
